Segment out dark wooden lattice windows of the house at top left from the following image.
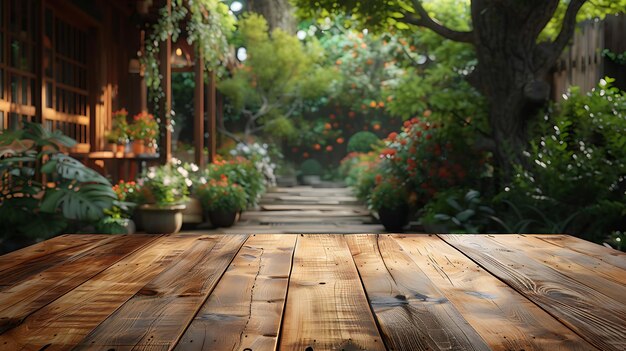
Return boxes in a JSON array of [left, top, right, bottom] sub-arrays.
[[0, 0, 89, 149]]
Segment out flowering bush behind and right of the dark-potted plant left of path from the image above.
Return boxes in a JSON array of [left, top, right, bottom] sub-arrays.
[[208, 156, 265, 206]]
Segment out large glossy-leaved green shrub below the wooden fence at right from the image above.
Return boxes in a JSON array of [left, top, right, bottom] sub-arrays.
[[498, 78, 626, 242]]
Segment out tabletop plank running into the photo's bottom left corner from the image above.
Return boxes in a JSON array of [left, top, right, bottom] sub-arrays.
[[0, 235, 200, 350]]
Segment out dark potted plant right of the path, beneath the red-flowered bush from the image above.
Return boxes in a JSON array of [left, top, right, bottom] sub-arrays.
[[369, 174, 409, 233]]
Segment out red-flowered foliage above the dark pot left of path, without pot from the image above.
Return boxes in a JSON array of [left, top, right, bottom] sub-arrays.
[[195, 174, 247, 212]]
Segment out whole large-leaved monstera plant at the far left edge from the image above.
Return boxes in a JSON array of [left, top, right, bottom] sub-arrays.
[[0, 122, 118, 251]]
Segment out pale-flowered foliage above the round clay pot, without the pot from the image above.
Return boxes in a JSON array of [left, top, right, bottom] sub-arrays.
[[138, 163, 193, 207]]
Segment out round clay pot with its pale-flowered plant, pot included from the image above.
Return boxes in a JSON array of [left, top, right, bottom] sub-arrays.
[[138, 163, 190, 234]]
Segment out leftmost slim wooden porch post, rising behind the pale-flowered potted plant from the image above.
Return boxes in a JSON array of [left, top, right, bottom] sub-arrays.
[[159, 0, 172, 163]]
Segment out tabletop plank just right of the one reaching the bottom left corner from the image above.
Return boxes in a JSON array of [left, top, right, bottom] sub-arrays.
[[76, 235, 247, 350]]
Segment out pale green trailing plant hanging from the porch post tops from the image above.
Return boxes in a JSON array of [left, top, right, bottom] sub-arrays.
[[140, 0, 235, 122]]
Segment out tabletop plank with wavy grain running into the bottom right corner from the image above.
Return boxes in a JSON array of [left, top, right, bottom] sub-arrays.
[[440, 235, 626, 351]]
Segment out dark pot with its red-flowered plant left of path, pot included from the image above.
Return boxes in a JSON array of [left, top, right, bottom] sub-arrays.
[[196, 174, 246, 228]]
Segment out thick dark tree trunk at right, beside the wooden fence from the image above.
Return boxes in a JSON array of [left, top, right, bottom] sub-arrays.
[[472, 0, 558, 182]]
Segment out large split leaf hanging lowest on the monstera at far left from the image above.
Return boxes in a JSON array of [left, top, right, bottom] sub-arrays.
[[41, 184, 117, 221]]
